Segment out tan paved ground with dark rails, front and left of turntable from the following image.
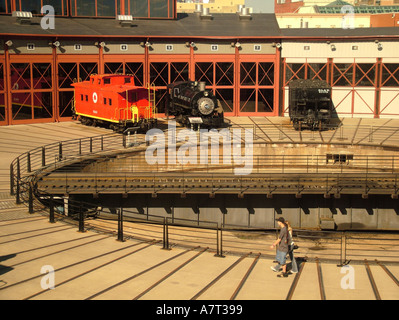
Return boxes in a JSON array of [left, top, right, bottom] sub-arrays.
[[0, 119, 399, 303]]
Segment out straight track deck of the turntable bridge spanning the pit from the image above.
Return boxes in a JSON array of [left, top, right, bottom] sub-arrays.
[[37, 172, 399, 195]]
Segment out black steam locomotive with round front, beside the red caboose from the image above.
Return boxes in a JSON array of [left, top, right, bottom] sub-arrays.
[[167, 81, 224, 129]]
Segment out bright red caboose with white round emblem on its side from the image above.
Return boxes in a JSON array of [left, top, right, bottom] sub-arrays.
[[72, 74, 156, 132]]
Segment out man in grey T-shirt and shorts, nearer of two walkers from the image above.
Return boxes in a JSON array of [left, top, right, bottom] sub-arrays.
[[270, 217, 291, 278]]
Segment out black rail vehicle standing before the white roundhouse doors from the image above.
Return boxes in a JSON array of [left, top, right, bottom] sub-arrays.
[[289, 79, 332, 130]]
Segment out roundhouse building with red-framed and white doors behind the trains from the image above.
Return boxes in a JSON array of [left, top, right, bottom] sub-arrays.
[[0, 0, 399, 125]]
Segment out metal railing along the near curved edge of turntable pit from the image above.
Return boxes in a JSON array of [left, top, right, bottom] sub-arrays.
[[38, 196, 399, 265]]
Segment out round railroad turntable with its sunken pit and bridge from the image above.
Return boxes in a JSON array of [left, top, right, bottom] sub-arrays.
[[20, 116, 399, 230]]
